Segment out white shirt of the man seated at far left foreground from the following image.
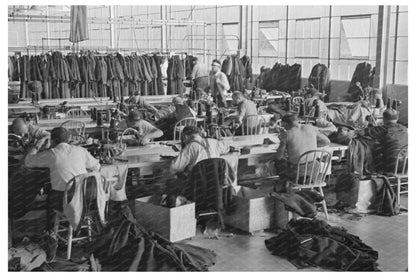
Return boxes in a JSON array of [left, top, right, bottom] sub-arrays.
[[25, 143, 100, 191]]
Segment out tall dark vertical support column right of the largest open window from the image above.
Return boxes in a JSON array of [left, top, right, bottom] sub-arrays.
[[373, 6, 391, 99]]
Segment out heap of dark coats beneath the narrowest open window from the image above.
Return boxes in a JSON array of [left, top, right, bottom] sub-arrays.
[[262, 63, 302, 92]]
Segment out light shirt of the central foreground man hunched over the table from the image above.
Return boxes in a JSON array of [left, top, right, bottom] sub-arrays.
[[171, 138, 230, 172]]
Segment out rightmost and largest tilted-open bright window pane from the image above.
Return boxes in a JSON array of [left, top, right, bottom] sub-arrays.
[[339, 16, 371, 60]]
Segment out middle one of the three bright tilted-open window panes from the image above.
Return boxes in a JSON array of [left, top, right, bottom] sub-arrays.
[[295, 18, 320, 59]]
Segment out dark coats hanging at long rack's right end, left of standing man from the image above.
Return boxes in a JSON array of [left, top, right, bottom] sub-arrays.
[[167, 55, 184, 95]]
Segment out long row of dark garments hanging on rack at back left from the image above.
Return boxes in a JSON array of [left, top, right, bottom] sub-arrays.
[[9, 52, 169, 99]]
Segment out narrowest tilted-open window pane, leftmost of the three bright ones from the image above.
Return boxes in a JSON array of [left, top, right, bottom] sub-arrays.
[[259, 21, 279, 57]]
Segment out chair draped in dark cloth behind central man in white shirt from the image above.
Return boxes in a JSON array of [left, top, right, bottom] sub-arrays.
[[182, 158, 232, 229]]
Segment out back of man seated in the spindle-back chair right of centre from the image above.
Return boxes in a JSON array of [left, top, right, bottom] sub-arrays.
[[286, 125, 318, 164]]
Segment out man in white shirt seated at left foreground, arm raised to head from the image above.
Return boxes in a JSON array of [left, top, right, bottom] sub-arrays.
[[25, 127, 100, 231]]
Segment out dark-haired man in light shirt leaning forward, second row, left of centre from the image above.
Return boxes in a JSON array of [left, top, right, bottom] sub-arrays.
[[117, 111, 163, 145]]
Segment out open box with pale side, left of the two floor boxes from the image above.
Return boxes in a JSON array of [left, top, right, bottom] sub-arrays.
[[135, 196, 196, 242]]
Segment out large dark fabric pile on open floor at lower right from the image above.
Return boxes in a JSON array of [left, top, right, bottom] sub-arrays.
[[265, 218, 379, 271]]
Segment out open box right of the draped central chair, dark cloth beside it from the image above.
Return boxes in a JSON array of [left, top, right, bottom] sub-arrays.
[[224, 187, 274, 233]]
